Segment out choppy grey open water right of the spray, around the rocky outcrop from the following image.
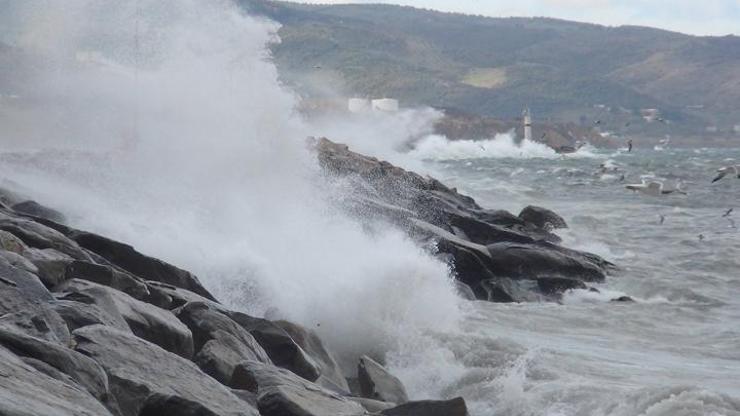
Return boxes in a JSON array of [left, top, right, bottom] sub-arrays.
[[405, 144, 740, 416]]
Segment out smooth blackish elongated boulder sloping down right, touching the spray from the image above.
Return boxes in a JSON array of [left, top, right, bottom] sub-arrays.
[[224, 311, 321, 381]]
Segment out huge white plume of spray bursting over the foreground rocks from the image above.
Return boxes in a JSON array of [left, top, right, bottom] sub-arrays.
[[1, 0, 459, 382]]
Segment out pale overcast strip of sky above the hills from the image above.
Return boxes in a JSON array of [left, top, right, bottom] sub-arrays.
[[290, 0, 740, 35]]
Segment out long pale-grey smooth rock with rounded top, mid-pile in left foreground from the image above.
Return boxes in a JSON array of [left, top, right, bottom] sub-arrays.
[[59, 279, 193, 359]]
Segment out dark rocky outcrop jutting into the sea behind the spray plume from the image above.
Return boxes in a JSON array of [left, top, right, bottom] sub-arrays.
[[314, 139, 613, 302]]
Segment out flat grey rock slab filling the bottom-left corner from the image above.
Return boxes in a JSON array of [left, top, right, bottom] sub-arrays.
[[0, 347, 112, 416]]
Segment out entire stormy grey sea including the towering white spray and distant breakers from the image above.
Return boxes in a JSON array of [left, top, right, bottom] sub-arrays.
[[0, 0, 740, 416]]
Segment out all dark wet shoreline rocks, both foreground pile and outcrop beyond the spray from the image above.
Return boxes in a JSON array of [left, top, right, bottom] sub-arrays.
[[0, 139, 613, 416]]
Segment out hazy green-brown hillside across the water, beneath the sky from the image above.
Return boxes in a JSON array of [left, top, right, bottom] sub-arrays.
[[241, 0, 740, 140]]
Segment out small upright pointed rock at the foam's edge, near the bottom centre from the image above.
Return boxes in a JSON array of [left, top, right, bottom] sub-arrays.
[[357, 355, 409, 404]]
